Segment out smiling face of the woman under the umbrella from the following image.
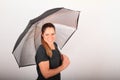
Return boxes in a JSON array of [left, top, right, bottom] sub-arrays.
[[42, 27, 55, 44]]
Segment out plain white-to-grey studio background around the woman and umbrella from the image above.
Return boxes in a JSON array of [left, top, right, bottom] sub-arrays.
[[0, 0, 120, 80]]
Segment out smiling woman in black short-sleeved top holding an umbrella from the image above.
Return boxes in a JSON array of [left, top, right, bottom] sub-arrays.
[[35, 23, 70, 80]]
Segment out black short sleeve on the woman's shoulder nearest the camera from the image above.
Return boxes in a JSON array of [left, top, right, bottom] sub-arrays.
[[35, 45, 49, 64]]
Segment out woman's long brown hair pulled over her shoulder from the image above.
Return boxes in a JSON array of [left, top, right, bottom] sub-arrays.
[[41, 23, 55, 57]]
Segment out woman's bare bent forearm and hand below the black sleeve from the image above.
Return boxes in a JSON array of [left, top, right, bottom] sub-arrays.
[[39, 54, 70, 78]]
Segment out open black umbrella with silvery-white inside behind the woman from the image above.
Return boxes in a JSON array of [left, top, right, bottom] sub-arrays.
[[12, 8, 80, 67]]
